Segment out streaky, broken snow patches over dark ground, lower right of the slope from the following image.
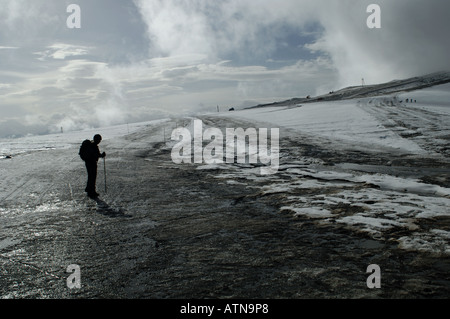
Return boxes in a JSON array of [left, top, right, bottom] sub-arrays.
[[214, 161, 450, 254]]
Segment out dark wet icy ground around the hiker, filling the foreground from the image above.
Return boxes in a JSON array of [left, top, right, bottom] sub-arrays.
[[0, 112, 450, 299]]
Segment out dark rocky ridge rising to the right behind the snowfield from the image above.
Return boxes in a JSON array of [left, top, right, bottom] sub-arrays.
[[250, 72, 450, 108]]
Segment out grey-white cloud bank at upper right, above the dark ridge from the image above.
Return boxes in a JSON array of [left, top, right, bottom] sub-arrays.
[[308, 0, 450, 86]]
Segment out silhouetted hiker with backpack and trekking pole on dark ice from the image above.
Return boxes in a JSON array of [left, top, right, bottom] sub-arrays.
[[79, 134, 106, 198]]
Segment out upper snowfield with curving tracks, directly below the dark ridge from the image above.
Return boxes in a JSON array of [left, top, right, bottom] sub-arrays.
[[222, 79, 450, 154]]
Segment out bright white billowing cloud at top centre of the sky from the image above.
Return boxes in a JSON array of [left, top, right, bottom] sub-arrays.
[[135, 0, 311, 60]]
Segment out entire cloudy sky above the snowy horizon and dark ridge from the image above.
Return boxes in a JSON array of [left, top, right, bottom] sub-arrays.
[[0, 0, 450, 137]]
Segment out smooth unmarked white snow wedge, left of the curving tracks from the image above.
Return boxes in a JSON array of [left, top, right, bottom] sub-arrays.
[[221, 100, 423, 153]]
